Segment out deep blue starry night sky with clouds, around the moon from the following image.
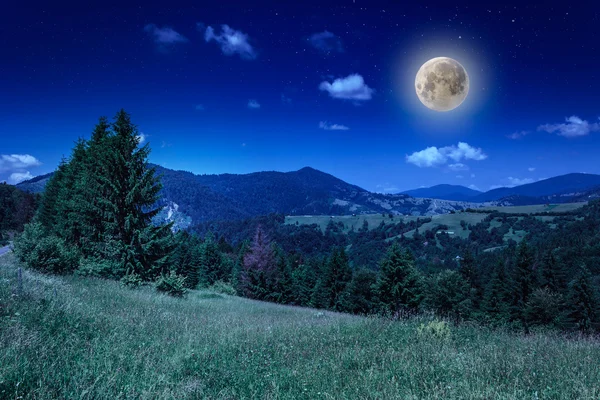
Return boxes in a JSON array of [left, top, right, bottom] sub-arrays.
[[0, 0, 600, 192]]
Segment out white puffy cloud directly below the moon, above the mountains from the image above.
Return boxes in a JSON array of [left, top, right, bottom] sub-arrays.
[[406, 142, 487, 167]]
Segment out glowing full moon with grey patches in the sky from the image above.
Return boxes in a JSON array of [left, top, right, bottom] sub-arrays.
[[415, 57, 469, 111]]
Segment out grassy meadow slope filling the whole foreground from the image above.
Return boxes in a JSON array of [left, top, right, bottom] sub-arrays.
[[0, 254, 600, 399]]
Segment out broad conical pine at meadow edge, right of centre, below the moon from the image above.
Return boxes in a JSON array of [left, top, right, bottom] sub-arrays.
[[376, 243, 423, 315]]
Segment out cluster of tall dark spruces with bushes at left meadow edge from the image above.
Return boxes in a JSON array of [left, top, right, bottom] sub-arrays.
[[15, 110, 173, 280]]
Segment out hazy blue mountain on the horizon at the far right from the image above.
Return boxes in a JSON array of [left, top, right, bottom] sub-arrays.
[[472, 173, 600, 203]]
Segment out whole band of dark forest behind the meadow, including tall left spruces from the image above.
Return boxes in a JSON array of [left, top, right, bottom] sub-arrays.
[[5, 110, 600, 333]]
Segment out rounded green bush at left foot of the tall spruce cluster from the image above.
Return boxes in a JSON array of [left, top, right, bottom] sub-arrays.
[[25, 236, 79, 274]]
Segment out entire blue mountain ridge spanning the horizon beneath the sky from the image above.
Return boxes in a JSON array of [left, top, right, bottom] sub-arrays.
[[17, 165, 600, 227]]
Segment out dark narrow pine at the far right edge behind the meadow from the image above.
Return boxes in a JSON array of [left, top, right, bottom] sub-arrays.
[[566, 266, 600, 332]]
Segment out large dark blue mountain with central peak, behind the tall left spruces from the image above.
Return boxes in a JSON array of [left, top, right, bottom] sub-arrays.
[[18, 165, 488, 223]]
